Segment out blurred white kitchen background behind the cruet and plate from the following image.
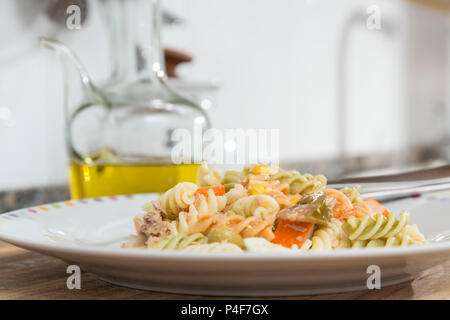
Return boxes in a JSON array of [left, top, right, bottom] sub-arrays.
[[0, 0, 450, 212]]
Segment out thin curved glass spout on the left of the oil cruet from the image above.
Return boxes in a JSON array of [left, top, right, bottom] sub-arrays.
[[39, 37, 97, 115]]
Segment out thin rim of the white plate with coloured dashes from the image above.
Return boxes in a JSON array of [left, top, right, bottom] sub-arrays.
[[0, 193, 450, 261]]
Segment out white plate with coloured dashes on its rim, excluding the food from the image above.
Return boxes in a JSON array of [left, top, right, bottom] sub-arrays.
[[0, 191, 450, 296]]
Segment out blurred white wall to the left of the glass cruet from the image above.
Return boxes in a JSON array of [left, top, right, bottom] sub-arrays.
[[0, 0, 106, 190]]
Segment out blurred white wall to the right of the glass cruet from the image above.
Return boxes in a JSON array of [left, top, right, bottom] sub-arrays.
[[164, 0, 447, 160]]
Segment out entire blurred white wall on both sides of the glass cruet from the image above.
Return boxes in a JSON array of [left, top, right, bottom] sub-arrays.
[[0, 0, 446, 190]]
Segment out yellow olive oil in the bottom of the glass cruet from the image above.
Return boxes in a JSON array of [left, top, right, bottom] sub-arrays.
[[70, 163, 199, 199]]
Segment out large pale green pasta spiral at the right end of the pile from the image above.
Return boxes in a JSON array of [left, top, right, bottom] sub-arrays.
[[342, 210, 409, 240]]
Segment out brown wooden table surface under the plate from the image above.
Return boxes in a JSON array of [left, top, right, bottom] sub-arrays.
[[0, 241, 450, 300]]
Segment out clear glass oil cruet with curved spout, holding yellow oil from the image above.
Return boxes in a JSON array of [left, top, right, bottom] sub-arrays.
[[40, 0, 209, 199]]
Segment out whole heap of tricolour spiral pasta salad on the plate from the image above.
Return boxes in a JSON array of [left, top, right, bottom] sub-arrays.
[[122, 163, 425, 252]]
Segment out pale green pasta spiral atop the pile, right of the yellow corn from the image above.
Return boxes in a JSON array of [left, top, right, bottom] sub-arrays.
[[270, 169, 327, 194]]
